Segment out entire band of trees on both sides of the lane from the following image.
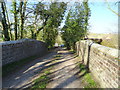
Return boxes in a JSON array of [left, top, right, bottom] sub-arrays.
[[0, 0, 90, 49]]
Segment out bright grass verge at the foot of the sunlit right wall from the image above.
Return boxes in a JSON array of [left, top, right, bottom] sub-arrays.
[[79, 64, 99, 88]]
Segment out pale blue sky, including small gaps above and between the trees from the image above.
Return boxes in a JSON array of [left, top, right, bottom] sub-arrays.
[[3, 0, 119, 33]]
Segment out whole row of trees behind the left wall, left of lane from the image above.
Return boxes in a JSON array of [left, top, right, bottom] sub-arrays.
[[1, 0, 67, 45]]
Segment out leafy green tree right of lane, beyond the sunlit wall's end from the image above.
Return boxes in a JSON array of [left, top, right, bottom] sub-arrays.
[[62, 2, 90, 49]]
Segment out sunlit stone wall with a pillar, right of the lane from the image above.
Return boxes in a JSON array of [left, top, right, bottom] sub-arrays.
[[76, 40, 120, 88]]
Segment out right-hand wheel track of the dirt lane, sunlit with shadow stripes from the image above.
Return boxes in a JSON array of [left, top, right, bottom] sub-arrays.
[[47, 50, 83, 88]]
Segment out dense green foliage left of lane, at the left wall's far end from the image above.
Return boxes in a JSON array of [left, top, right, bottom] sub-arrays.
[[39, 2, 66, 48]]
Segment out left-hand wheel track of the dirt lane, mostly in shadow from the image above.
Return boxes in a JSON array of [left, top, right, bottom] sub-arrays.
[[2, 50, 57, 88]]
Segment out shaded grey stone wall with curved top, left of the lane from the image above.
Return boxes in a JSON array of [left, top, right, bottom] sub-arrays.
[[0, 39, 47, 65]]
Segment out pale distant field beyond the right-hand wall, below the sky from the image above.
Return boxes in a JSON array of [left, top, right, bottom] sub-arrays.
[[88, 33, 120, 49]]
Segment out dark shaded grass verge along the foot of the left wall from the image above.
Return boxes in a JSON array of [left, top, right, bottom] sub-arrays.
[[2, 55, 43, 77]]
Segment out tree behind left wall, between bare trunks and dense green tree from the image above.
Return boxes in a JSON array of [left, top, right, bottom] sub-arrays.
[[27, 2, 49, 39]]
